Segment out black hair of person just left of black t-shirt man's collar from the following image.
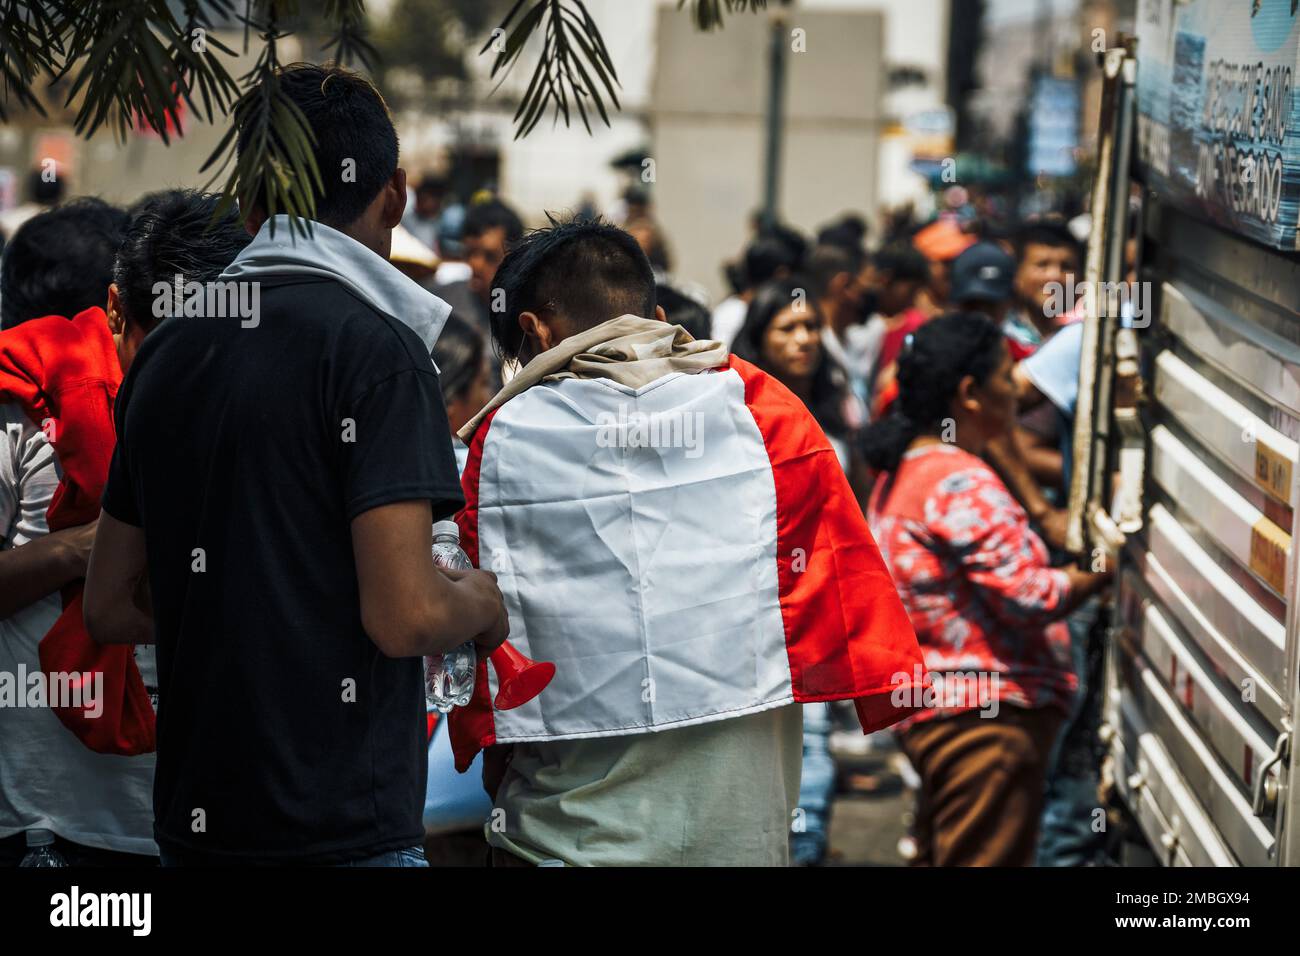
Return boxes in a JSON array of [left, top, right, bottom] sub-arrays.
[[113, 189, 252, 332]]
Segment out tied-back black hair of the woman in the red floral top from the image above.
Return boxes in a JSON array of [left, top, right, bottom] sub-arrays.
[[862, 312, 1006, 472]]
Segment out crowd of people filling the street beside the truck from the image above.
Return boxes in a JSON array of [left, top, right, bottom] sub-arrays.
[[0, 57, 1109, 866]]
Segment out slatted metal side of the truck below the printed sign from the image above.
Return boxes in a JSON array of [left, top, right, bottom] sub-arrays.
[[1108, 203, 1300, 865]]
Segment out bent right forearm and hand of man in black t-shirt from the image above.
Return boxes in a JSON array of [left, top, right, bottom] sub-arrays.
[[352, 501, 510, 657]]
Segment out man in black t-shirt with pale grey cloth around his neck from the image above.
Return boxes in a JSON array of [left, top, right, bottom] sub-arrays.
[[85, 65, 508, 866]]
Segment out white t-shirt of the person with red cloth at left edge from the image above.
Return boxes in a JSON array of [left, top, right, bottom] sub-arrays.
[[0, 405, 159, 856]]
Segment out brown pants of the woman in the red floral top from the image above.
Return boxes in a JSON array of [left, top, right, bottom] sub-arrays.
[[900, 705, 1063, 866]]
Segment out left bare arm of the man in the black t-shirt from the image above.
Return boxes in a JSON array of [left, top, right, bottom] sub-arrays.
[[82, 511, 153, 644]]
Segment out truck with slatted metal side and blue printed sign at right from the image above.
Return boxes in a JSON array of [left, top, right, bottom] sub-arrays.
[[1067, 0, 1300, 866]]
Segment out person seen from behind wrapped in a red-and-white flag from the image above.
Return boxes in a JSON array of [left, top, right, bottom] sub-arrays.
[[451, 221, 923, 865]]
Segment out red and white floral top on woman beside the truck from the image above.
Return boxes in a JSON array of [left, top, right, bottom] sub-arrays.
[[867, 444, 1078, 730]]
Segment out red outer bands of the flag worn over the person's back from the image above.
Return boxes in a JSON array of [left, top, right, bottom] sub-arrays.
[[449, 355, 924, 773]]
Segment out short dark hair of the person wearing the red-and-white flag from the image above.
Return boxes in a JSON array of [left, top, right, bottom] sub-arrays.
[[491, 216, 657, 359]]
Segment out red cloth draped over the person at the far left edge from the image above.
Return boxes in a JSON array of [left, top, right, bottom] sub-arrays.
[[0, 308, 155, 756]]
